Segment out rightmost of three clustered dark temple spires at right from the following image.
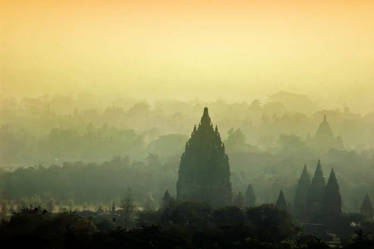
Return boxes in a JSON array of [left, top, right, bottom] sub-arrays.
[[322, 169, 342, 217]]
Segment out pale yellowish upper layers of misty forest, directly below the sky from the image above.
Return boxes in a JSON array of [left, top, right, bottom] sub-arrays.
[[0, 91, 374, 167]]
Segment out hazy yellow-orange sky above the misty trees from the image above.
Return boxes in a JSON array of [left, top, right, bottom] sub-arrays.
[[0, 0, 374, 110]]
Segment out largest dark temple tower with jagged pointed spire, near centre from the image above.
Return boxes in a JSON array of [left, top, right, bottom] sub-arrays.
[[177, 107, 232, 207]]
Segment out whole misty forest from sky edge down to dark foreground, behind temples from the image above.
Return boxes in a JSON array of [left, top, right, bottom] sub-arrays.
[[0, 92, 374, 212]]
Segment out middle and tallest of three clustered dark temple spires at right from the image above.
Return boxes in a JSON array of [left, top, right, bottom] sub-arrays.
[[307, 160, 325, 220]]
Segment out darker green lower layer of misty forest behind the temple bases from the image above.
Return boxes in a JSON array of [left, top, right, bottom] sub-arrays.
[[0, 150, 374, 212]]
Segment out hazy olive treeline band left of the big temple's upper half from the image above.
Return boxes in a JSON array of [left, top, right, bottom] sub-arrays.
[[0, 124, 185, 168]]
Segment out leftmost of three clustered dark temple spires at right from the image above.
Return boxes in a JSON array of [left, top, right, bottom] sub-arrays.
[[294, 165, 311, 218]]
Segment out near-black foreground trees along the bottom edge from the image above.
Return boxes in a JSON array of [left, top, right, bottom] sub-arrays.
[[0, 203, 374, 249]]
